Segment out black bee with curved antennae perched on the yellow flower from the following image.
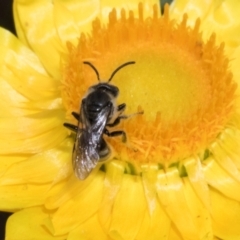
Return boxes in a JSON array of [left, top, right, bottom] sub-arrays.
[[64, 61, 135, 180]]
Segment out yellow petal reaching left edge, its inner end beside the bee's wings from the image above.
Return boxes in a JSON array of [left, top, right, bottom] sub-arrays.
[[1, 139, 73, 185]]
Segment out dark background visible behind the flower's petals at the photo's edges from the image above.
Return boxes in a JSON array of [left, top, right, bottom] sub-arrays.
[[0, 0, 173, 240]]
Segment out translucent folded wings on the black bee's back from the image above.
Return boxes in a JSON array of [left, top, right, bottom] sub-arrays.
[[72, 103, 111, 180]]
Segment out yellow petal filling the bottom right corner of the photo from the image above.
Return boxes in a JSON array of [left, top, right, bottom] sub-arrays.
[[210, 189, 240, 240]]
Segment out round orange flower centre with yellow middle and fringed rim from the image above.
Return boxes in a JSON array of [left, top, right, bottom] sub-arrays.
[[62, 4, 236, 166]]
